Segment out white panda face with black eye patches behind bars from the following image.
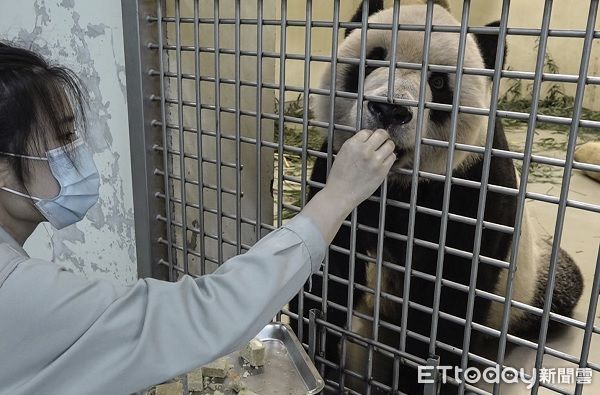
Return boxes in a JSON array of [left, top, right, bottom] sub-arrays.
[[315, 5, 490, 181]]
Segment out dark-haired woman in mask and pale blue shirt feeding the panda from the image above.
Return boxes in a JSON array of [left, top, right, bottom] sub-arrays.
[[0, 44, 395, 395]]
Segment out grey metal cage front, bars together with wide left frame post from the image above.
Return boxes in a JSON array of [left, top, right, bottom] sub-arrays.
[[122, 0, 600, 394]]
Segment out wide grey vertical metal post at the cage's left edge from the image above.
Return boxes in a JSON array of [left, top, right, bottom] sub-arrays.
[[121, 0, 168, 279]]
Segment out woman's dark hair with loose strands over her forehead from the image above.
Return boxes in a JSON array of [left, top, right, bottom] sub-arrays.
[[0, 42, 87, 183]]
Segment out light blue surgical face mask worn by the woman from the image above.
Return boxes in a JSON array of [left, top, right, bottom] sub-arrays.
[[1, 138, 100, 229]]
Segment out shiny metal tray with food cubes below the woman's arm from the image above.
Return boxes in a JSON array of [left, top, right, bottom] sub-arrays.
[[199, 322, 325, 395]]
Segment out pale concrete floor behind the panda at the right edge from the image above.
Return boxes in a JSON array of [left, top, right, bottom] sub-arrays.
[[478, 129, 600, 395]]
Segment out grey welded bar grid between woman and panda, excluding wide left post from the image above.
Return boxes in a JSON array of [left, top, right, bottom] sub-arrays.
[[146, 0, 600, 394]]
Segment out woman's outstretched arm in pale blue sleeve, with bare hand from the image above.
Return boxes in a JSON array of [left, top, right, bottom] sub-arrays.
[[0, 131, 394, 394]]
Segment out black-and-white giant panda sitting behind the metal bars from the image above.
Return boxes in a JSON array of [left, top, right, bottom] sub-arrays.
[[289, 0, 583, 395]]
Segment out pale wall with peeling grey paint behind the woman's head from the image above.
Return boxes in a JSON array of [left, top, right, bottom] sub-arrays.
[[0, 0, 137, 284]]
